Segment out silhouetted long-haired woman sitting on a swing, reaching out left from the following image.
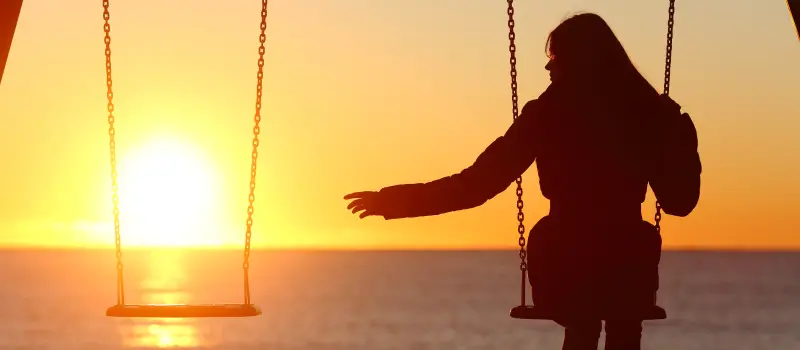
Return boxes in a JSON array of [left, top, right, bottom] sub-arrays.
[[345, 13, 701, 350]]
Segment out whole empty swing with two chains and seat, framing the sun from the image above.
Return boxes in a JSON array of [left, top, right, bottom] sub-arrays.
[[103, 0, 267, 318]]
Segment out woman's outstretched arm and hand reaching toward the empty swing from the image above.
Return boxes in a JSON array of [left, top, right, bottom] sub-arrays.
[[345, 100, 540, 220]]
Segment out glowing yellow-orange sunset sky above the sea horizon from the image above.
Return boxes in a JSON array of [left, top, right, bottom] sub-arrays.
[[0, 0, 800, 248]]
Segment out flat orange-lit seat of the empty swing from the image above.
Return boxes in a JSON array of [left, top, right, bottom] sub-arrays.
[[106, 304, 261, 318]]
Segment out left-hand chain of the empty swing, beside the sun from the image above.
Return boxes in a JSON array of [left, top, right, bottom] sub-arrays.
[[103, 0, 125, 305]]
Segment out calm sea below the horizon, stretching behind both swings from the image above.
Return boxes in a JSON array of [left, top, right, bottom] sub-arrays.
[[0, 250, 800, 350]]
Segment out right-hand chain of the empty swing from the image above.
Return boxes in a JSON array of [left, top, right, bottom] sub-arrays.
[[242, 0, 268, 305]]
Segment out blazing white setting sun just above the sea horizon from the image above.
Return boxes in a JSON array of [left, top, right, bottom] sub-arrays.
[[119, 139, 227, 246]]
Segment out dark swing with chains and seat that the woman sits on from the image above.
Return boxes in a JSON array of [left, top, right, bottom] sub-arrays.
[[506, 0, 675, 320]]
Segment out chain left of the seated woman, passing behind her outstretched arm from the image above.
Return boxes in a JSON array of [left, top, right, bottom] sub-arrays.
[[507, 0, 527, 298]]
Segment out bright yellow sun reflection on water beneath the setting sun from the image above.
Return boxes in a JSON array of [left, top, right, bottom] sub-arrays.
[[123, 251, 204, 348]]
